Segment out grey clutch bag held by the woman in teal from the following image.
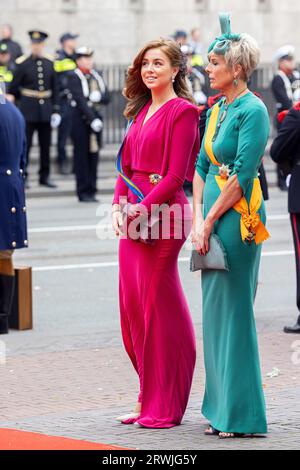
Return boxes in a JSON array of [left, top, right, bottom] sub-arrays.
[[190, 233, 229, 272]]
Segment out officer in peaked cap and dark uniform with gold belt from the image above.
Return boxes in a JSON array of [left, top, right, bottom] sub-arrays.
[[10, 30, 61, 188]]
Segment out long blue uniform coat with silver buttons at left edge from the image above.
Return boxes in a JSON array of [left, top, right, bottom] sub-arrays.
[[0, 102, 27, 250]]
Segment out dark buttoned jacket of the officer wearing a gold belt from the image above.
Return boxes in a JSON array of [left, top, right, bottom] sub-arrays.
[[10, 55, 59, 123]]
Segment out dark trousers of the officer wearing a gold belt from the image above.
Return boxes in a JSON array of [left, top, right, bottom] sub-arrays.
[[26, 122, 51, 182]]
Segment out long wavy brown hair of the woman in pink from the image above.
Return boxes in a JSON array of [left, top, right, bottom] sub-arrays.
[[123, 39, 195, 119]]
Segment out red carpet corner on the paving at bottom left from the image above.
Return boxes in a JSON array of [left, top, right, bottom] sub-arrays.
[[0, 429, 124, 450]]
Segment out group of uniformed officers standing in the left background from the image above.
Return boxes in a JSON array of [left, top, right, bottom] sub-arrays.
[[0, 25, 109, 202]]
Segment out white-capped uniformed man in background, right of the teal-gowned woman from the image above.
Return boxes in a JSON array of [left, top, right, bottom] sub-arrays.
[[271, 45, 300, 191]]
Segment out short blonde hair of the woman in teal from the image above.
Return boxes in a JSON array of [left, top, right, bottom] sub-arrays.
[[224, 33, 260, 82]]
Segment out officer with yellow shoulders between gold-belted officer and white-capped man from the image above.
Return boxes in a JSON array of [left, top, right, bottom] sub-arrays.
[[54, 33, 78, 175]]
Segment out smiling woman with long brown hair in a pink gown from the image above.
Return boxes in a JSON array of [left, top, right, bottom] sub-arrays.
[[112, 40, 200, 428]]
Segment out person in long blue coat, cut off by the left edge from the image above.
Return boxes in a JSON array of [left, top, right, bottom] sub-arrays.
[[0, 98, 28, 334]]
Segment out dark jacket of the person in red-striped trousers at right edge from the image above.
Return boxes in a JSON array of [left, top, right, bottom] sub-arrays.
[[271, 107, 300, 214]]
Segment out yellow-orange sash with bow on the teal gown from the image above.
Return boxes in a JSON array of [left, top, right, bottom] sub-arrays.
[[204, 105, 270, 245]]
